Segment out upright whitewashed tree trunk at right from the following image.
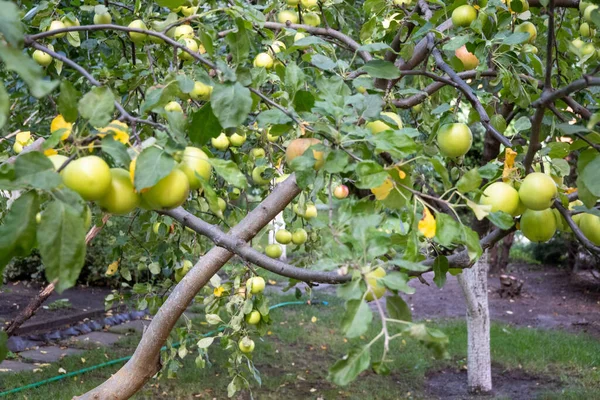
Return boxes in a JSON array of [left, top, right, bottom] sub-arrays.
[[458, 252, 492, 393]]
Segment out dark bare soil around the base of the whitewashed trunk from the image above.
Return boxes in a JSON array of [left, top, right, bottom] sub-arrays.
[[425, 365, 560, 400]]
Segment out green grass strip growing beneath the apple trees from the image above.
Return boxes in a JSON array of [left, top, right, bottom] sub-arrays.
[[0, 296, 600, 400]]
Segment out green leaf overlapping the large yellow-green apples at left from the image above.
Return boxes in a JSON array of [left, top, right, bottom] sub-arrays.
[[134, 147, 175, 191]]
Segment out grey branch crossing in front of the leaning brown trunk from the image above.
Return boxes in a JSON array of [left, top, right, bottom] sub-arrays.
[[162, 207, 352, 283]]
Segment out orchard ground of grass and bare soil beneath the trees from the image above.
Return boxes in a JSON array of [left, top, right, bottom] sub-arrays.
[[0, 265, 600, 399]]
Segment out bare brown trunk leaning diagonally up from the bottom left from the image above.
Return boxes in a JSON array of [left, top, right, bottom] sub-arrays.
[[78, 174, 300, 400]]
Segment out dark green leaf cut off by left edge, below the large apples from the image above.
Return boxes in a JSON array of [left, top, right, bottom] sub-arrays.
[[0, 191, 40, 275]]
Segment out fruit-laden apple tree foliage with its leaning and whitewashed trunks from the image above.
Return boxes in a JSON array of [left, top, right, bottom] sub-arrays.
[[0, 0, 600, 399]]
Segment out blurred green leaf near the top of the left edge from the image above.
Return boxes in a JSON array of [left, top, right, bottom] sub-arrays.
[[0, 45, 58, 98]]
